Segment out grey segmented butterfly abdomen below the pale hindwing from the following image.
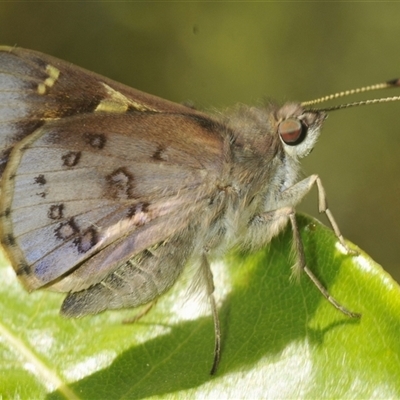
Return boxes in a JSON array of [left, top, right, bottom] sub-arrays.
[[61, 229, 196, 317]]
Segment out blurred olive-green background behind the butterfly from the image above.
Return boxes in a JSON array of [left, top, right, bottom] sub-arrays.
[[0, 2, 400, 281]]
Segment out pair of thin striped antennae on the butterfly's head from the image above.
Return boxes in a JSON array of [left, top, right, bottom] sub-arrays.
[[300, 79, 400, 112]]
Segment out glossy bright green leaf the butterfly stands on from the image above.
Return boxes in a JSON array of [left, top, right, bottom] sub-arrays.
[[0, 216, 400, 399]]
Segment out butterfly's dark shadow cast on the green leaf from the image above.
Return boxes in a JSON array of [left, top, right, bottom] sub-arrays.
[[49, 216, 360, 399]]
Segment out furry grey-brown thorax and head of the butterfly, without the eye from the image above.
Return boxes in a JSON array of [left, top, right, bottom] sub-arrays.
[[200, 104, 321, 253]]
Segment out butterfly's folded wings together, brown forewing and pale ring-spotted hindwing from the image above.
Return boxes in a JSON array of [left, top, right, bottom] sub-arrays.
[[0, 49, 228, 291]]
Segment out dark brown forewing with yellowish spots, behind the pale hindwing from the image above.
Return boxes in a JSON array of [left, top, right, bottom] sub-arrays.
[[0, 46, 209, 173]]
